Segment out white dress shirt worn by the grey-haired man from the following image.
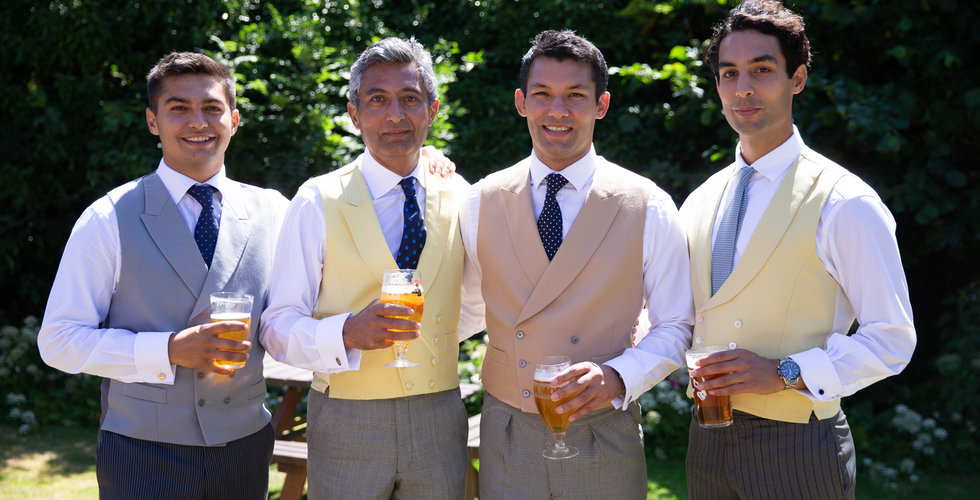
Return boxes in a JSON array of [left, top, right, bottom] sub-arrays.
[[261, 153, 485, 374]]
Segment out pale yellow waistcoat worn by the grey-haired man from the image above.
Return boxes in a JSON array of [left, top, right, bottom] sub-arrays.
[[313, 162, 463, 399]]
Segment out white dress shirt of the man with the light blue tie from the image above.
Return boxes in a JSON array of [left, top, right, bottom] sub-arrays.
[[711, 126, 916, 401]]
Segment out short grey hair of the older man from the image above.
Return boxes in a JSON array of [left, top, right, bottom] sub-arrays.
[[347, 36, 439, 109]]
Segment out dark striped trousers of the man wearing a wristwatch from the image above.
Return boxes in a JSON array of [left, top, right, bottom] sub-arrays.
[[687, 412, 856, 500]]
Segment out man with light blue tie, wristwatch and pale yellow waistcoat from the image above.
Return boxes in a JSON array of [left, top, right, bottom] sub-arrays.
[[681, 0, 916, 499]]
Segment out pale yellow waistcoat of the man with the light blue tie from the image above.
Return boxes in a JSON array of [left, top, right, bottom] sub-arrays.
[[680, 148, 853, 423]]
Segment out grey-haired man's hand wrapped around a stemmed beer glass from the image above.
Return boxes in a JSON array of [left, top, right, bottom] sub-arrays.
[[343, 299, 422, 351]]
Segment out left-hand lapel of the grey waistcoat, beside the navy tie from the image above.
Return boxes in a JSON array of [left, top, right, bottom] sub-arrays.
[[140, 174, 207, 297]]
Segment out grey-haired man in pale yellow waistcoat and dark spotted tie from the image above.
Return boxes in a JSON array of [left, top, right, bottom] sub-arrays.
[[262, 38, 483, 499]]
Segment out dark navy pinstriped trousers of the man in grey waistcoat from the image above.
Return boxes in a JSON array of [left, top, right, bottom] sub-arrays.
[[95, 424, 274, 500]]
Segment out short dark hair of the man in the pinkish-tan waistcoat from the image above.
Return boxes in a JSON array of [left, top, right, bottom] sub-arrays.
[[521, 30, 609, 103]]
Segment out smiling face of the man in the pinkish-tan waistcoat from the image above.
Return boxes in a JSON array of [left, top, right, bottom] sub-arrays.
[[514, 57, 609, 171]]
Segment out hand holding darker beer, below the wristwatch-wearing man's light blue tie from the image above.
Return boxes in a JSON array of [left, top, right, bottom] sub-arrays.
[[691, 349, 792, 396]]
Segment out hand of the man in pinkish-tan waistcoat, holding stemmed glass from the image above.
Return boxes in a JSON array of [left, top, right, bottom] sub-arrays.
[[551, 362, 626, 422]]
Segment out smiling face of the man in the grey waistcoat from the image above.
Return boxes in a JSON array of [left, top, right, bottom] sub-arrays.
[[146, 74, 238, 182]]
